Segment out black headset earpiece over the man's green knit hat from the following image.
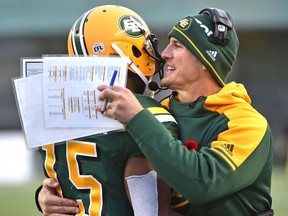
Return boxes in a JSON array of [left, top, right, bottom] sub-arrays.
[[199, 8, 233, 46]]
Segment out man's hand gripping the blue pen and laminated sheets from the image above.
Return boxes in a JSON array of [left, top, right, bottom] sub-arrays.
[[97, 85, 143, 124]]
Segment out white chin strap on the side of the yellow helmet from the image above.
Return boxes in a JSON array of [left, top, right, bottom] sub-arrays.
[[111, 43, 154, 97]]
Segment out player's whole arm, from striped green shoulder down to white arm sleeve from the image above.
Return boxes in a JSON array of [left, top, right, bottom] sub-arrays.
[[124, 95, 180, 216]]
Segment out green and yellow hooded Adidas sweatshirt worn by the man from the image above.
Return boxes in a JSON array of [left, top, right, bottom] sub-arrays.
[[126, 82, 273, 216]]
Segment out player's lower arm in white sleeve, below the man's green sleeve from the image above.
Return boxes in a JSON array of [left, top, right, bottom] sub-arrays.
[[124, 156, 181, 216]]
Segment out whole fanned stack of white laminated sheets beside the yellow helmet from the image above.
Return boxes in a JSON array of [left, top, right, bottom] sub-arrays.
[[13, 57, 127, 149]]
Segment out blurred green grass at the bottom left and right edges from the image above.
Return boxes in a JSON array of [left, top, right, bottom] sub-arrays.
[[0, 168, 288, 216]]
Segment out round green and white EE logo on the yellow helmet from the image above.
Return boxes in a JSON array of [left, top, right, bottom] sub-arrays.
[[118, 15, 142, 37]]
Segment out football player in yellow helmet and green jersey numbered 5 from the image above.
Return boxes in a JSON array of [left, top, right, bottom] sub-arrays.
[[36, 5, 178, 216]]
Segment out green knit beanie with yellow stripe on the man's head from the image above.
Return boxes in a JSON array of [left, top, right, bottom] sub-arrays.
[[168, 14, 239, 87]]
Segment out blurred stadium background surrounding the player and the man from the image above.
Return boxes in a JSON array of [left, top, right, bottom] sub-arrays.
[[0, 0, 288, 216]]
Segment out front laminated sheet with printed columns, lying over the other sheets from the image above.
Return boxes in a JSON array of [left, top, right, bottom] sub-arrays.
[[43, 57, 127, 127]]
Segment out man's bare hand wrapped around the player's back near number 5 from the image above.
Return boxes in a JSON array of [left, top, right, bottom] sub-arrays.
[[38, 178, 80, 216]]
